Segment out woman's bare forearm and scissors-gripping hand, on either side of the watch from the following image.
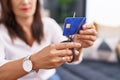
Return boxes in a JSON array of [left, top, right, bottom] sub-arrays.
[[0, 43, 81, 80]]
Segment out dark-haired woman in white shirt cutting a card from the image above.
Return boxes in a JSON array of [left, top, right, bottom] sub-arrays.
[[0, 0, 97, 80]]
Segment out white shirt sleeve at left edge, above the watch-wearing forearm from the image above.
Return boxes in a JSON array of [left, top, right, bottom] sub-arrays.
[[0, 39, 9, 66]]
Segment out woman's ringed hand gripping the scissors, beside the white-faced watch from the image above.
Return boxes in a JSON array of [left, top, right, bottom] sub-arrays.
[[31, 42, 81, 70]]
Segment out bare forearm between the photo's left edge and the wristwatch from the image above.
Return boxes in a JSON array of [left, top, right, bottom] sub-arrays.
[[0, 58, 27, 80]]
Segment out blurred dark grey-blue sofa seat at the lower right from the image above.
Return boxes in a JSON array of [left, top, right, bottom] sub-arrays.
[[57, 59, 120, 80]]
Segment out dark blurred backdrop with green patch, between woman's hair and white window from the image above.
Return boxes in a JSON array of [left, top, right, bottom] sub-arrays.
[[44, 0, 86, 23]]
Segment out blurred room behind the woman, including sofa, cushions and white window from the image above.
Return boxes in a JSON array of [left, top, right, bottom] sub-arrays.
[[42, 0, 120, 80]]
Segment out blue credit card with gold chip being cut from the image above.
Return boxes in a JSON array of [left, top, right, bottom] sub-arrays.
[[63, 17, 86, 36]]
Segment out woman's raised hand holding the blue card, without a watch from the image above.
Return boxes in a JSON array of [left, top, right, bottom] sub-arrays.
[[74, 24, 97, 48]]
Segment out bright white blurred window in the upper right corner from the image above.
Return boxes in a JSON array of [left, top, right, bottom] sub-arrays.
[[86, 0, 120, 25]]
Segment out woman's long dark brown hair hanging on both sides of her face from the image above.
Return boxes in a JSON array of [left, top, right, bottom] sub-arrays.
[[0, 0, 44, 44]]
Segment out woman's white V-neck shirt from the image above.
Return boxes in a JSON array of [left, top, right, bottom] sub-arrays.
[[0, 18, 82, 80]]
